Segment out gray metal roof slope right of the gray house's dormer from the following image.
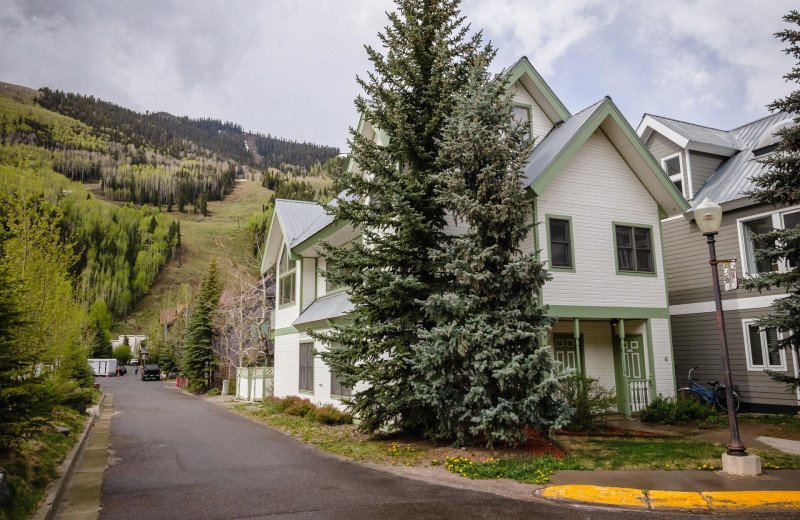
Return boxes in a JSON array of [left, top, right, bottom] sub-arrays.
[[694, 113, 790, 205]]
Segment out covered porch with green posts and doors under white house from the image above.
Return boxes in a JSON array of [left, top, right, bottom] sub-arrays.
[[548, 317, 674, 418]]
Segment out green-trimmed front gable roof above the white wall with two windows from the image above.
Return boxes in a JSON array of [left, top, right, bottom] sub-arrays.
[[523, 96, 689, 216]]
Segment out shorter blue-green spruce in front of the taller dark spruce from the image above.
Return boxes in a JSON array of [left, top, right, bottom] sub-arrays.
[[415, 61, 570, 446]]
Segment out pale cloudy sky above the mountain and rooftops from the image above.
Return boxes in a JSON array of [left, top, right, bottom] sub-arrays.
[[0, 0, 797, 150]]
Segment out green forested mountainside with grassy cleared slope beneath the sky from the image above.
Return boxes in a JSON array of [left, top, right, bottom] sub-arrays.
[[0, 83, 338, 335]]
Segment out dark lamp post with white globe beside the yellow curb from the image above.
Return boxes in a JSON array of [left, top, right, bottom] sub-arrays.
[[694, 198, 747, 457]]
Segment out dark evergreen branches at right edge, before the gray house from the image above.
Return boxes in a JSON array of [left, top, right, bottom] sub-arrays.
[[743, 11, 800, 390]]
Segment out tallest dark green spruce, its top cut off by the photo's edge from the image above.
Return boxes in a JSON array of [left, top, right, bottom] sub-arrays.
[[315, 0, 487, 430]]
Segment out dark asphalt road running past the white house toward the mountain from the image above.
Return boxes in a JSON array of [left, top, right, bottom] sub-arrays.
[[97, 376, 763, 520]]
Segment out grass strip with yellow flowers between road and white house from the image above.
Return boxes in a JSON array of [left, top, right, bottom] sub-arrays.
[[234, 403, 800, 484]]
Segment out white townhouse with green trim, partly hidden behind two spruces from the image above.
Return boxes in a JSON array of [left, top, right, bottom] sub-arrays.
[[261, 57, 688, 414]]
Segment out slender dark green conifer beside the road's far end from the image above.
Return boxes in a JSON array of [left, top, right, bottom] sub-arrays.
[[183, 260, 222, 390]]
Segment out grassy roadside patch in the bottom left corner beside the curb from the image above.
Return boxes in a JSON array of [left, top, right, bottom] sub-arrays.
[[0, 406, 89, 520]]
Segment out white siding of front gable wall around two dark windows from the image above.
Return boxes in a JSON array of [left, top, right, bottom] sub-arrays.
[[537, 131, 667, 308]]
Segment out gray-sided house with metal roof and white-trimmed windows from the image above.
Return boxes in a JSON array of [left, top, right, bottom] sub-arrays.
[[637, 113, 800, 412]]
